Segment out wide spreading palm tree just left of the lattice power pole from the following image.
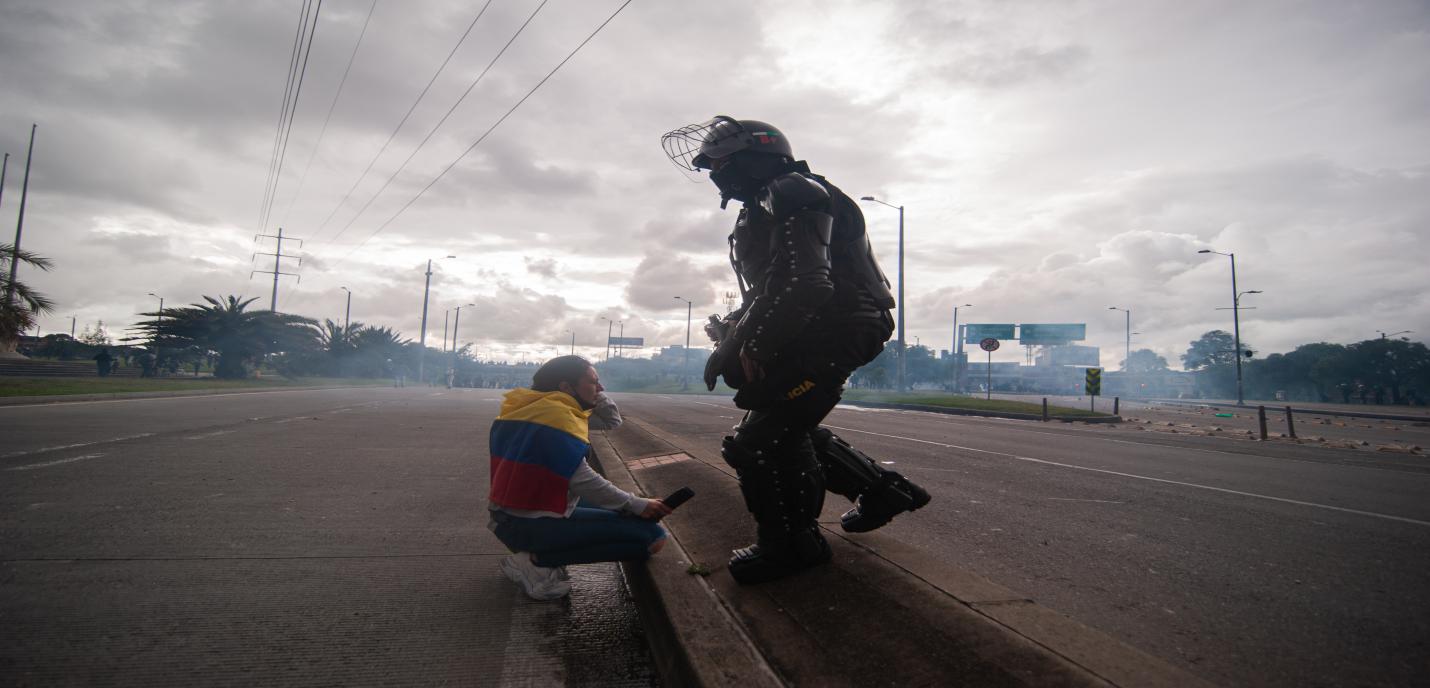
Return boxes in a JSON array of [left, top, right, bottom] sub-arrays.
[[134, 296, 316, 378]]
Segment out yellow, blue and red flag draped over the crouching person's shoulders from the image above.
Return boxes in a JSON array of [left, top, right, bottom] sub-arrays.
[[490, 389, 591, 515]]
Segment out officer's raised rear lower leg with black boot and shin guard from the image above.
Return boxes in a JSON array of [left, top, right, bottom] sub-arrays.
[[809, 428, 930, 532]]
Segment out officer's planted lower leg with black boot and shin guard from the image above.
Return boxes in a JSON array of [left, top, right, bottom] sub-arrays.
[[721, 438, 831, 585]]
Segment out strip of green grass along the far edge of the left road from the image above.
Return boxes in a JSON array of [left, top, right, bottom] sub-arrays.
[[0, 378, 392, 396]]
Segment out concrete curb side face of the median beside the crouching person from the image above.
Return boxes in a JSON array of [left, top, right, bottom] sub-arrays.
[[591, 432, 785, 688]]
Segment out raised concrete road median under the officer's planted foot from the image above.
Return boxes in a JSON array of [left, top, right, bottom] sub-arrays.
[[593, 418, 1205, 687]]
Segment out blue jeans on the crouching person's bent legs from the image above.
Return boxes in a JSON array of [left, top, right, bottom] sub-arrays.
[[492, 506, 665, 566]]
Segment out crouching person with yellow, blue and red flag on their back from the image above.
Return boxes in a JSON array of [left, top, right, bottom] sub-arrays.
[[488, 356, 671, 599]]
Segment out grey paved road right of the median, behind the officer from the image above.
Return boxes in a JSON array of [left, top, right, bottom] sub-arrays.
[[618, 395, 1430, 687]]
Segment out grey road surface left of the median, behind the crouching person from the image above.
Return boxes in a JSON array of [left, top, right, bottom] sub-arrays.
[[0, 388, 656, 687]]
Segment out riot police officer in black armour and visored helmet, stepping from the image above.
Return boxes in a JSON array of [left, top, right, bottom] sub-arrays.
[[661, 116, 930, 584]]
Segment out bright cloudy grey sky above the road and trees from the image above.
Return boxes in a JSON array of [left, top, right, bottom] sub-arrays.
[[0, 0, 1430, 368]]
